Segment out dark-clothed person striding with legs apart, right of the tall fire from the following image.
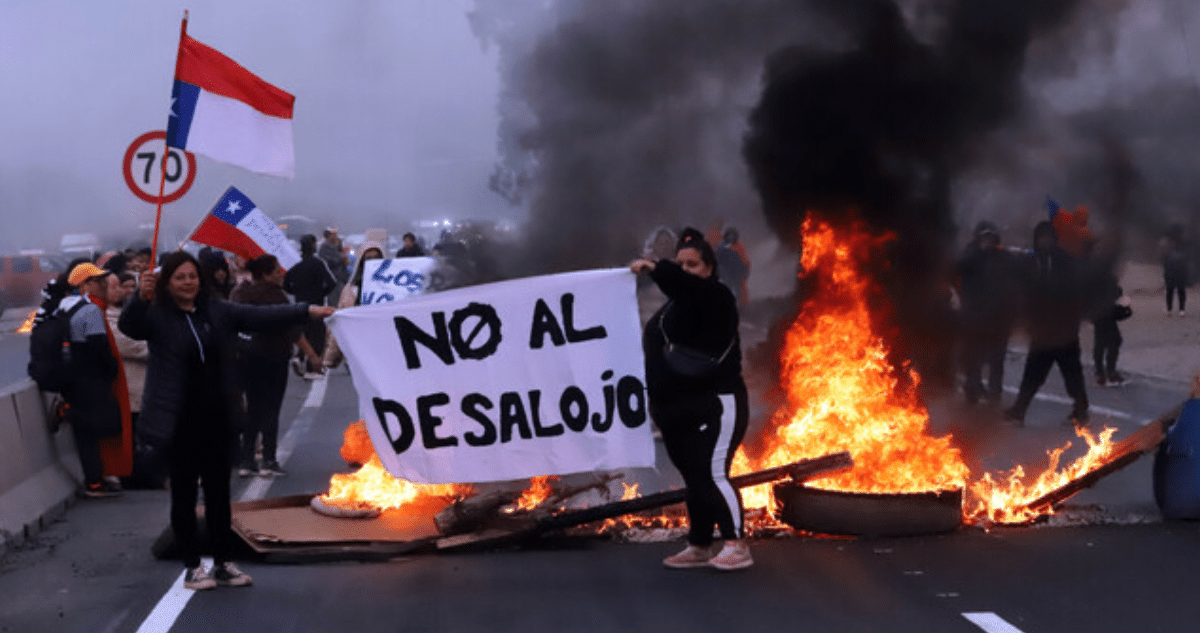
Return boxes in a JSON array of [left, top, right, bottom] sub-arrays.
[[1006, 222, 1087, 428]]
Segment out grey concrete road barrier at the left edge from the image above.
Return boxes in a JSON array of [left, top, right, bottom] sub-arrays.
[[0, 379, 83, 553]]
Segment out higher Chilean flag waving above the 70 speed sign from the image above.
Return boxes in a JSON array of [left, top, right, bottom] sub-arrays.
[[167, 30, 296, 177]]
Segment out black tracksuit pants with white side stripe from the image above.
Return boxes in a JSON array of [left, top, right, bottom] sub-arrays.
[[650, 388, 750, 547]]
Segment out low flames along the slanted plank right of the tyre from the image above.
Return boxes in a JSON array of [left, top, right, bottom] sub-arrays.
[[967, 428, 1117, 524]]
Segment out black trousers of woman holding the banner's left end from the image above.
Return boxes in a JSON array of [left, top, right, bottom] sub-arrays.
[[168, 435, 233, 567]]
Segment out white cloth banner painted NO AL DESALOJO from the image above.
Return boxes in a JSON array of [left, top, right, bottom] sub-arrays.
[[329, 269, 654, 483]]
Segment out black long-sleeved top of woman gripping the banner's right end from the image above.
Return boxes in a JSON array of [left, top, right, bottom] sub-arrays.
[[642, 259, 745, 400]]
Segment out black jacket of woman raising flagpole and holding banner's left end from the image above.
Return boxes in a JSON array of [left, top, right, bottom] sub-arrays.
[[118, 295, 308, 446]]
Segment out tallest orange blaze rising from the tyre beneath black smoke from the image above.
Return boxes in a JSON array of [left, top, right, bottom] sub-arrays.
[[734, 217, 970, 508]]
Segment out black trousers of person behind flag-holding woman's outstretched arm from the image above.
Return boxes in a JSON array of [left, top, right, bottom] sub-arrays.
[[241, 355, 288, 464]]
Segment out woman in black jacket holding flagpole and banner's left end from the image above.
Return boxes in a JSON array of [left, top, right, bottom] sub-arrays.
[[118, 252, 334, 589]]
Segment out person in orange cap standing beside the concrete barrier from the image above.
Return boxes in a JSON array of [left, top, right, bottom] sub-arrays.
[[58, 263, 130, 499]]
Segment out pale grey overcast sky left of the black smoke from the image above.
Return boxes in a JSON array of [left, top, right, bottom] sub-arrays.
[[0, 0, 506, 249]]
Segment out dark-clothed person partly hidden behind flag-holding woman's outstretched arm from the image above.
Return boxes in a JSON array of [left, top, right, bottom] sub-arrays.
[[229, 254, 300, 477]]
